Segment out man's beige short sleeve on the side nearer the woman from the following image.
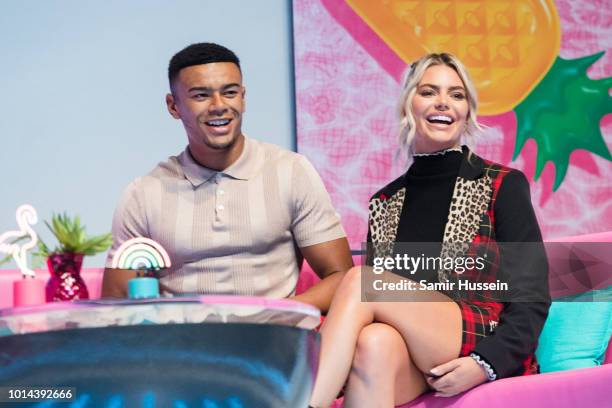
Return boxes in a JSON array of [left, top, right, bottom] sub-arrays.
[[291, 155, 346, 248]]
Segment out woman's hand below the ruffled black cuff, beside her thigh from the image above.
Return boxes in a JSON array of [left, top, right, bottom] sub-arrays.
[[427, 357, 487, 397]]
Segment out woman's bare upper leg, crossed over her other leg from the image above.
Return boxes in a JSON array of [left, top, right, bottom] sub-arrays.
[[310, 267, 462, 407]]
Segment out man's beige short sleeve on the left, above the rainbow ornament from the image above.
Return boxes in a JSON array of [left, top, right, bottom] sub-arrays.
[[106, 179, 149, 268]]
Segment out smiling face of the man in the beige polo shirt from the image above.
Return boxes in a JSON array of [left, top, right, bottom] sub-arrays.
[[166, 62, 245, 156]]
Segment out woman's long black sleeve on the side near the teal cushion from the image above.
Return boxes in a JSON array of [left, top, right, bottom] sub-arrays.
[[474, 170, 550, 378]]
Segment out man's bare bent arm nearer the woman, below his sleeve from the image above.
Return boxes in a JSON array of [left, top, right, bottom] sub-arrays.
[[292, 238, 353, 313]]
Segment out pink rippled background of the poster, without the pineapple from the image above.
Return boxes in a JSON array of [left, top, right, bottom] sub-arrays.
[[293, 0, 612, 249]]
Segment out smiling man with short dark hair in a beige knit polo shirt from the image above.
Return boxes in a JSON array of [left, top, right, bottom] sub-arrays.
[[102, 43, 352, 311]]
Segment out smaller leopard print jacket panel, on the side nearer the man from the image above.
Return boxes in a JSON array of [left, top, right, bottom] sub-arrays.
[[368, 188, 406, 257]]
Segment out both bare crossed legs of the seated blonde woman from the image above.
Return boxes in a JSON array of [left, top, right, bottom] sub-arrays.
[[311, 267, 462, 407]]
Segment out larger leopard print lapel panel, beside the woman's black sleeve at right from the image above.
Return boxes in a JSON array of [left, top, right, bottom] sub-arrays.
[[438, 175, 493, 282]]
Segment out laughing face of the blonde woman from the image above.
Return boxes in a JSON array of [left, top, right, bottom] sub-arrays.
[[406, 65, 469, 153]]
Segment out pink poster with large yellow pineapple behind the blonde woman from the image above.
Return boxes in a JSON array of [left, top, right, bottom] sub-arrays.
[[293, 0, 612, 245]]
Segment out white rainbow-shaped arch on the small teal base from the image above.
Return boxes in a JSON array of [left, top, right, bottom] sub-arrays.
[[112, 237, 172, 270]]
